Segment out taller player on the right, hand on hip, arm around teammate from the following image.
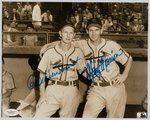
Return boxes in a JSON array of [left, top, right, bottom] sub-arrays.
[[41, 18, 132, 118]]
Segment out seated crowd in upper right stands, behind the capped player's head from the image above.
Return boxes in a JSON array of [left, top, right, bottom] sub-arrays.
[[66, 3, 145, 33]]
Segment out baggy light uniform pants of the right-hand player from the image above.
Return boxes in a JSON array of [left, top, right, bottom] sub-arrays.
[[83, 84, 127, 118]]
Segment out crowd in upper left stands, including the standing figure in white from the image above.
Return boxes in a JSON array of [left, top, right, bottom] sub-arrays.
[[3, 2, 53, 27]]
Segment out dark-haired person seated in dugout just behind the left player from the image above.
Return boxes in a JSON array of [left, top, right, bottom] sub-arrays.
[[17, 55, 39, 117]]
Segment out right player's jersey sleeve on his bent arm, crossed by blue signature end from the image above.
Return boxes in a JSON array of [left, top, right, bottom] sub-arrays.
[[111, 42, 130, 65]]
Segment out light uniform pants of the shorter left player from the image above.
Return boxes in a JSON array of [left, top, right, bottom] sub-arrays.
[[35, 85, 81, 117]]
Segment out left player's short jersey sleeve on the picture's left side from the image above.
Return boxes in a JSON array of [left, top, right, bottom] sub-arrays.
[[38, 51, 50, 74]]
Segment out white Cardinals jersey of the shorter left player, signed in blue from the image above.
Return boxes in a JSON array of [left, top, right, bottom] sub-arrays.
[[38, 44, 85, 81]]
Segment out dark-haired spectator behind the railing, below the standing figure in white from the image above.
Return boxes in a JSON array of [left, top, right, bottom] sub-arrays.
[[23, 24, 38, 46]]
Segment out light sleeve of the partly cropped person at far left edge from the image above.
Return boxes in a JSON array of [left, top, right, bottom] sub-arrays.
[[6, 73, 16, 90]]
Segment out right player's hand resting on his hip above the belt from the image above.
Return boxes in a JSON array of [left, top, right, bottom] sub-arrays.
[[112, 74, 127, 87]]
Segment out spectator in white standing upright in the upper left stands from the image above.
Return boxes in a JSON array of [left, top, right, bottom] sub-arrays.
[[32, 2, 42, 29]]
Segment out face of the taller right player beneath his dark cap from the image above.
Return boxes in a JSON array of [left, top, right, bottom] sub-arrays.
[[87, 26, 101, 41]]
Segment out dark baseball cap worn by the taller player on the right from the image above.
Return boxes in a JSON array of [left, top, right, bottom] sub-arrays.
[[87, 18, 102, 29]]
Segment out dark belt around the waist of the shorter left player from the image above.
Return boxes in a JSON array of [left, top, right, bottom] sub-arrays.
[[48, 80, 78, 86]]
